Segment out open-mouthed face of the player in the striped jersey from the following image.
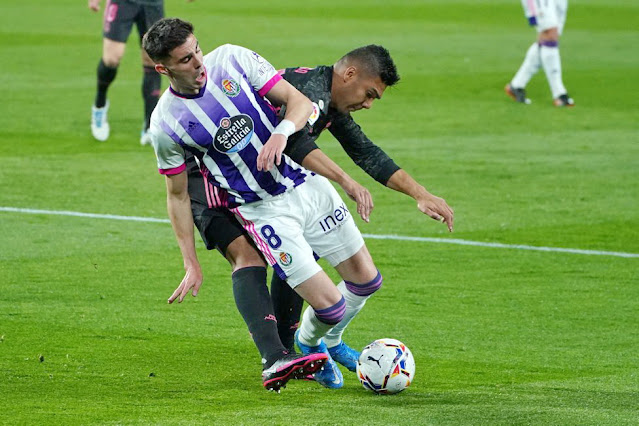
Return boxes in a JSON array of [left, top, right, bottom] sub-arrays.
[[156, 34, 206, 94]]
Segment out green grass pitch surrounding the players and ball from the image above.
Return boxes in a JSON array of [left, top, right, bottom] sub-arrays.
[[0, 0, 639, 424]]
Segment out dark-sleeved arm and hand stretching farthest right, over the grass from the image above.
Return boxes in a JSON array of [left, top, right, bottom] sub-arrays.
[[329, 115, 453, 232]]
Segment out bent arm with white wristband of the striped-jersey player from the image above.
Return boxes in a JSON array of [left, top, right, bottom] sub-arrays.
[[257, 79, 313, 171]]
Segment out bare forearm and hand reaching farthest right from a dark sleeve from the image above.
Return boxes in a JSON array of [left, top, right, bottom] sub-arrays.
[[386, 169, 454, 232]]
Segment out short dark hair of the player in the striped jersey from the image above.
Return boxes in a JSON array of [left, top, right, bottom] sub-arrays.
[[142, 18, 193, 62]]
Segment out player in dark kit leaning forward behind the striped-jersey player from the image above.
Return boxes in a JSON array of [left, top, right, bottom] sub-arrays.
[[187, 45, 453, 380]]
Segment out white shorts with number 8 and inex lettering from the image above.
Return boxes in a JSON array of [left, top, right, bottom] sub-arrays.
[[231, 175, 364, 287]]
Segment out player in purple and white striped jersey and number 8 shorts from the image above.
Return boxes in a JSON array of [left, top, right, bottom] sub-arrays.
[[143, 19, 382, 390]]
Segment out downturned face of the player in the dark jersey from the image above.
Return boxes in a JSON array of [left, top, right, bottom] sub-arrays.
[[332, 73, 386, 113]]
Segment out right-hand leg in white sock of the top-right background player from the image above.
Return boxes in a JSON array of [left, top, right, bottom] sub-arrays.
[[537, 0, 574, 106]]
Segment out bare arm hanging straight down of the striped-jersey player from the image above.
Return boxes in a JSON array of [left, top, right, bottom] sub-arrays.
[[166, 170, 202, 303]]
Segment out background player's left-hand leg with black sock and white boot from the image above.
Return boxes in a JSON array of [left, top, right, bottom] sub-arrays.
[[91, 38, 126, 141]]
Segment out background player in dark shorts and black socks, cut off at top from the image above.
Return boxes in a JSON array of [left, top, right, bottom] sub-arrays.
[[88, 0, 191, 145]]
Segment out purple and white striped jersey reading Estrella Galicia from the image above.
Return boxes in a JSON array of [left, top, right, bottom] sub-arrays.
[[150, 44, 310, 207]]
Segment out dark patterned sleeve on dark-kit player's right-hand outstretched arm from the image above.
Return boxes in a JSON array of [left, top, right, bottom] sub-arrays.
[[328, 114, 399, 185]]
